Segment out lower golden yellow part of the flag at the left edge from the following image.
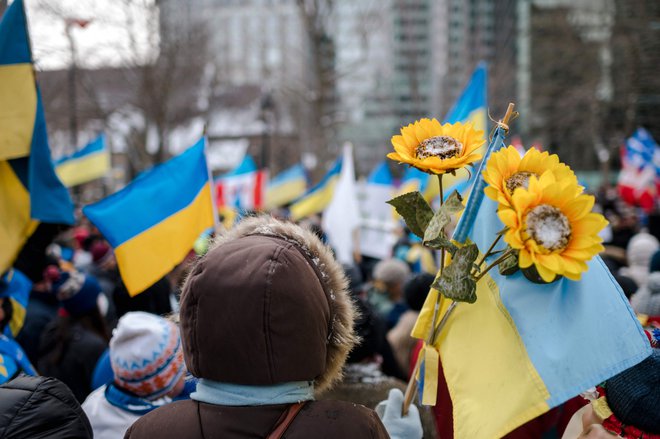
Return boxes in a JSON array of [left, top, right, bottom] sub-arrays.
[[0, 161, 38, 273]]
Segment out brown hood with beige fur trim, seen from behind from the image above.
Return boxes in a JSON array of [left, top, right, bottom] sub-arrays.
[[180, 216, 356, 392]]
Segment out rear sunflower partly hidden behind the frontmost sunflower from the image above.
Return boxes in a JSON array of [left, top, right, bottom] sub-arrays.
[[483, 146, 582, 207]]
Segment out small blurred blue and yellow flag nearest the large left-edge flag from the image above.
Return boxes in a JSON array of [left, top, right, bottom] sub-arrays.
[[55, 135, 110, 187]]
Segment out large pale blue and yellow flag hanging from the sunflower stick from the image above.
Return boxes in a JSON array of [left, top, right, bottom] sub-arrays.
[[413, 124, 651, 439]]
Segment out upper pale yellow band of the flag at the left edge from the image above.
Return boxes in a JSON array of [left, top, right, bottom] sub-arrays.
[[0, 64, 37, 161]]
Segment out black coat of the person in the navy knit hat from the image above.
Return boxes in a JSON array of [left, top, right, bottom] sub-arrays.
[[37, 320, 108, 403]]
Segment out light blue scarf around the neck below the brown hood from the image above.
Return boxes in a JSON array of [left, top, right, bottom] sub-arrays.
[[190, 378, 314, 406]]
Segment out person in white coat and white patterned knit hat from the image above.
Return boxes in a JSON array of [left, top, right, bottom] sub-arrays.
[[82, 312, 185, 439]]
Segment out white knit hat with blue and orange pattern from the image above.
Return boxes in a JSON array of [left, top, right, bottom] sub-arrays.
[[110, 312, 185, 400]]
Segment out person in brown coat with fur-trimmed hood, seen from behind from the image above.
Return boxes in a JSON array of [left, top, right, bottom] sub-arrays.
[[125, 217, 421, 439]]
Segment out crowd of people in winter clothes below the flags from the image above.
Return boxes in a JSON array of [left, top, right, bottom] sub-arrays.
[[0, 187, 660, 439]]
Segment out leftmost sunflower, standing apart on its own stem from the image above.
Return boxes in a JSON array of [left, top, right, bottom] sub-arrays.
[[387, 119, 486, 174]]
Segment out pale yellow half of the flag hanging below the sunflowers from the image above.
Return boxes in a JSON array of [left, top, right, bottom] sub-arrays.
[[436, 275, 550, 439]]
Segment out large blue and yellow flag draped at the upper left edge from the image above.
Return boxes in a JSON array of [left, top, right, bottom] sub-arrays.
[[0, 0, 73, 273]]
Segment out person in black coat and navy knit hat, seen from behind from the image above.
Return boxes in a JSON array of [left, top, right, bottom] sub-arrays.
[[37, 271, 110, 403]]
